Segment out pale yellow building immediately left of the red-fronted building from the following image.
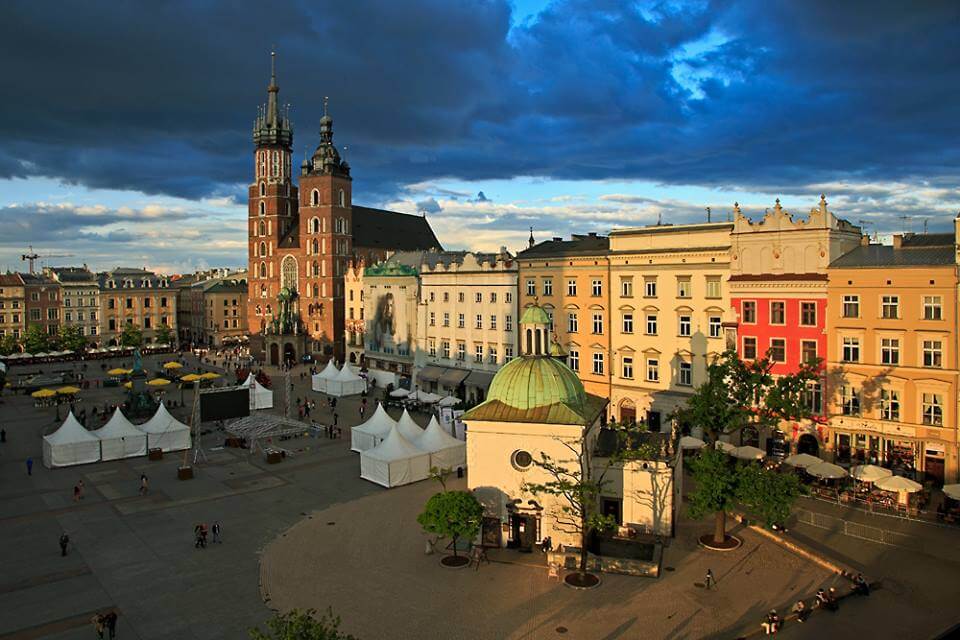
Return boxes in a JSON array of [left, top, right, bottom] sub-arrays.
[[608, 222, 733, 432]]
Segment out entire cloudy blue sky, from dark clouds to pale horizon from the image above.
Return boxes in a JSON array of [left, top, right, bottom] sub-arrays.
[[0, 0, 960, 271]]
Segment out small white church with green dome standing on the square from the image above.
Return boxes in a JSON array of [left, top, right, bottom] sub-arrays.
[[463, 305, 675, 548]]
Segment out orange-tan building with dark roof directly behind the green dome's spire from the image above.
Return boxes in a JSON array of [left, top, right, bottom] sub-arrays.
[[517, 233, 611, 398]]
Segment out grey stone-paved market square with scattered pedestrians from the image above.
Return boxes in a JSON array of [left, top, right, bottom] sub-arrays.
[[0, 356, 960, 640]]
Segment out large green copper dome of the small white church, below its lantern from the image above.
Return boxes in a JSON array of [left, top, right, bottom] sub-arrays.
[[487, 356, 587, 411]]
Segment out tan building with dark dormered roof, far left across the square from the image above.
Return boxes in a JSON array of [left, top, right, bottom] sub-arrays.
[[97, 268, 177, 346]]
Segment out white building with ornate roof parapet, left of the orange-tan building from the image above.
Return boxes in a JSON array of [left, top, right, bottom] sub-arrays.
[[415, 249, 519, 401]]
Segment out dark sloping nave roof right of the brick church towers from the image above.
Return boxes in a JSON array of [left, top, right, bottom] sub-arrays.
[[352, 205, 443, 251]]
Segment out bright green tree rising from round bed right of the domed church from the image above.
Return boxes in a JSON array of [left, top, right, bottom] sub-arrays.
[[687, 446, 738, 544]]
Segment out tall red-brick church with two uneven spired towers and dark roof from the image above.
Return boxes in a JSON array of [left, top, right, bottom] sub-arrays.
[[247, 55, 439, 364]]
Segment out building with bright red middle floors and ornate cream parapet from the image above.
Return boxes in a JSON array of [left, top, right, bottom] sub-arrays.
[[729, 196, 861, 455]]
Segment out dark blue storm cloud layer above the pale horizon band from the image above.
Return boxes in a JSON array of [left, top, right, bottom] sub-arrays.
[[0, 0, 960, 203]]
